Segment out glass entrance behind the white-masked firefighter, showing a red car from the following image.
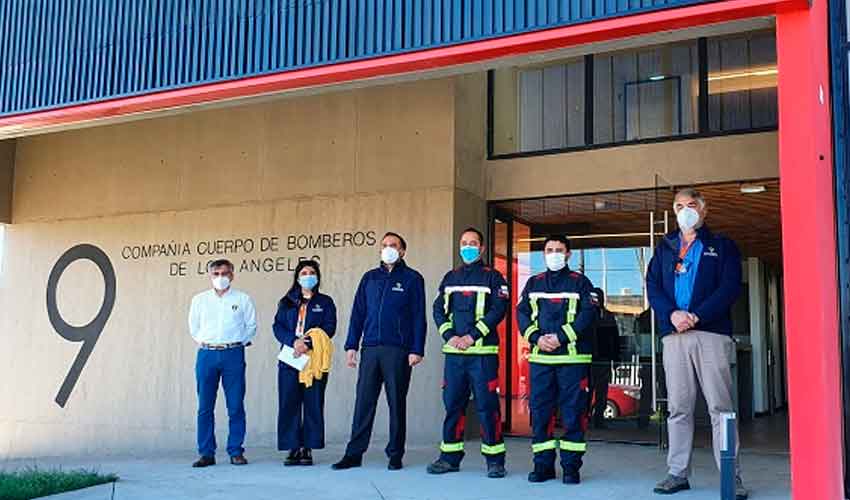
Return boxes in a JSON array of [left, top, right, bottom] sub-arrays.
[[490, 188, 665, 444]]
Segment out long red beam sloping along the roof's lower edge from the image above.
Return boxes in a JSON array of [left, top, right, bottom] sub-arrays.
[[0, 0, 807, 135]]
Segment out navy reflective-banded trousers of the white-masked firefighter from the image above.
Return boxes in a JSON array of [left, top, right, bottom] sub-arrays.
[[530, 363, 590, 473]]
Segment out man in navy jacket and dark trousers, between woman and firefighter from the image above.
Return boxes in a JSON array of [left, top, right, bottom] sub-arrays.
[[333, 233, 427, 470]]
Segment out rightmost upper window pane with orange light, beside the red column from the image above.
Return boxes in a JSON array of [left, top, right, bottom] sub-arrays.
[[708, 32, 779, 132]]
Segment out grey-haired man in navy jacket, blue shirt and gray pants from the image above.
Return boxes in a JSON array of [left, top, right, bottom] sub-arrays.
[[646, 189, 748, 500]]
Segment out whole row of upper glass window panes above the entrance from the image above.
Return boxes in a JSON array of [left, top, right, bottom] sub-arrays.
[[491, 31, 778, 156]]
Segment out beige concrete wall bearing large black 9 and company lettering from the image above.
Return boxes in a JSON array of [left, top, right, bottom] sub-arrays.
[[0, 80, 464, 457]]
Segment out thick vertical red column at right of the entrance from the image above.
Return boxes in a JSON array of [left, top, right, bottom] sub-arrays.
[[776, 1, 844, 499]]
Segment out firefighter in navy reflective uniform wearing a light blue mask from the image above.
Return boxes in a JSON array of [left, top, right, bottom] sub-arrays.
[[428, 228, 509, 478]]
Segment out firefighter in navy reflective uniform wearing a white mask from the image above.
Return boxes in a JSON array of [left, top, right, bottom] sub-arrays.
[[517, 236, 598, 484]]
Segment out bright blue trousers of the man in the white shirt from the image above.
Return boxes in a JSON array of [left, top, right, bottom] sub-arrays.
[[195, 347, 245, 457]]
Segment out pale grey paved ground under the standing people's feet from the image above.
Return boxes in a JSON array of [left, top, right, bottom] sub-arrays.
[[2, 439, 790, 500]]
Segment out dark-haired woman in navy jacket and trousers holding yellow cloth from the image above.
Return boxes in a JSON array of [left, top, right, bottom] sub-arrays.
[[272, 260, 336, 465]]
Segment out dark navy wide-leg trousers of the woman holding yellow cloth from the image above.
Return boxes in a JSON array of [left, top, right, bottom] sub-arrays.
[[277, 362, 329, 450]]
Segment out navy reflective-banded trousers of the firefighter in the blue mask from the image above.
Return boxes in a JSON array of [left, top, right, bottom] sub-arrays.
[[440, 354, 505, 465]]
